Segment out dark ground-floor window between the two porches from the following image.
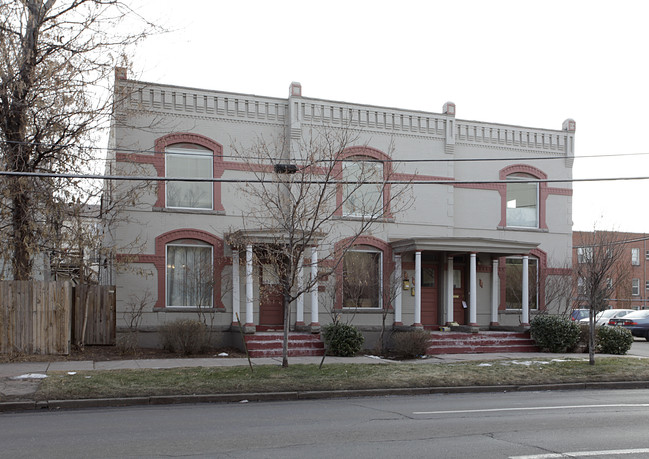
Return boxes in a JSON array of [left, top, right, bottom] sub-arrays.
[[343, 249, 383, 308]]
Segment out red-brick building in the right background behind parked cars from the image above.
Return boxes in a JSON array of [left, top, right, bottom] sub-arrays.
[[572, 231, 649, 309]]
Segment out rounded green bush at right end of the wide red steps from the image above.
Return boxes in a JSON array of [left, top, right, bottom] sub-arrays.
[[530, 314, 581, 352]]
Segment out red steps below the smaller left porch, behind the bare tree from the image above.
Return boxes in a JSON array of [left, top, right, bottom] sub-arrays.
[[244, 332, 324, 358]]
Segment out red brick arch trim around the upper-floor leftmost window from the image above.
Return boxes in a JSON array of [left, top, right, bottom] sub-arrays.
[[153, 132, 225, 211]]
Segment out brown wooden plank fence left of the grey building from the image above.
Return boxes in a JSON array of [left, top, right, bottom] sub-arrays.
[[0, 281, 116, 354]]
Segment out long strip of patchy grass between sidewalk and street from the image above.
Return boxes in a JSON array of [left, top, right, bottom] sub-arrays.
[[35, 357, 649, 400]]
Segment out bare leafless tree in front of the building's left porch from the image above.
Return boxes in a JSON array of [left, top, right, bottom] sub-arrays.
[[230, 126, 410, 366]]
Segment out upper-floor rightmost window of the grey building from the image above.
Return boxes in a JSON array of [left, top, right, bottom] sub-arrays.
[[506, 173, 539, 228]]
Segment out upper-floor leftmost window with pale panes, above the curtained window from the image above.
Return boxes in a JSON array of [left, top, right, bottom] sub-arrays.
[[165, 147, 213, 209]]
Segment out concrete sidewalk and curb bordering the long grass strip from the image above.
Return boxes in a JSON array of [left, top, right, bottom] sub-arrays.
[[0, 352, 649, 412]]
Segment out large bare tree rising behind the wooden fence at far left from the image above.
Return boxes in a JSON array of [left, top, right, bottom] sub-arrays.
[[0, 0, 152, 280]]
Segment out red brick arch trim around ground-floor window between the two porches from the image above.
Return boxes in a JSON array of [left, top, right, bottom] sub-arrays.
[[334, 236, 394, 311]]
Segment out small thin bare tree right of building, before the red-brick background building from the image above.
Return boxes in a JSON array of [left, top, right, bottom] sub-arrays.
[[575, 230, 629, 365]]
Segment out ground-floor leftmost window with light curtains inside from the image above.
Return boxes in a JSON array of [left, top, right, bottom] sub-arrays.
[[166, 241, 214, 307]]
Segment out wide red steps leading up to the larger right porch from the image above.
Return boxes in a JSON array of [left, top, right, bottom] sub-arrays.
[[426, 331, 539, 355]]
